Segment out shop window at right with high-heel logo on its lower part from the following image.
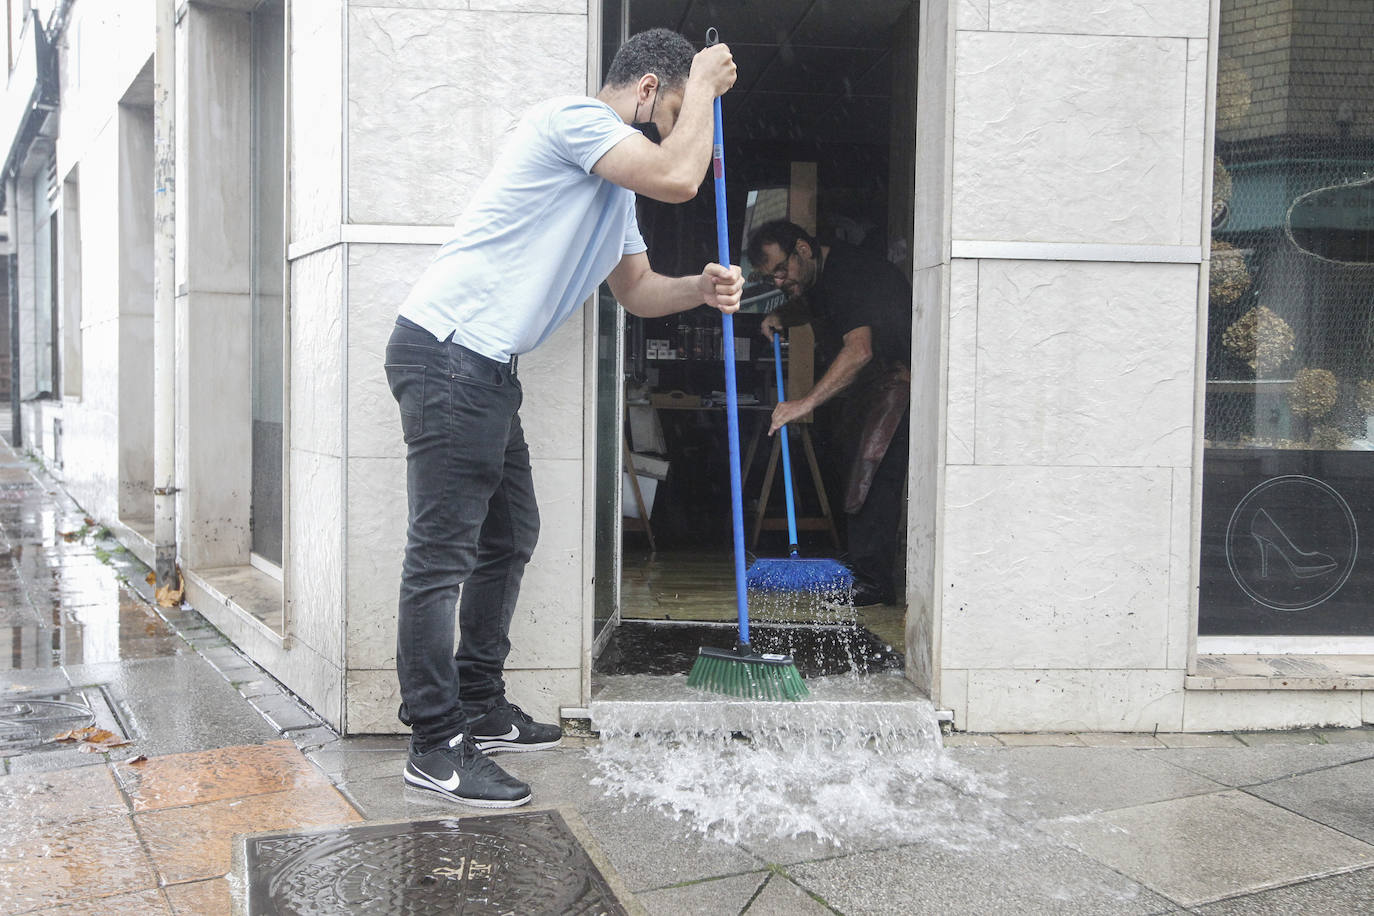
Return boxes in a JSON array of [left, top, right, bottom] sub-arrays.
[[1198, 0, 1374, 642]]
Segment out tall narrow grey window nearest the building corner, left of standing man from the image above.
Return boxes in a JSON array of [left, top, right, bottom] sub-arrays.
[[250, 0, 286, 571]]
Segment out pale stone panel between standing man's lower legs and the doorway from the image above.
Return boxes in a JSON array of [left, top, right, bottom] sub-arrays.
[[507, 459, 583, 670]]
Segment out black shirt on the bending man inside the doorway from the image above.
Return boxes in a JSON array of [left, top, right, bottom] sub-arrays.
[[807, 242, 911, 389]]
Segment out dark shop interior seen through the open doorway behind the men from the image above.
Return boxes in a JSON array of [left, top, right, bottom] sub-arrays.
[[596, 0, 916, 667]]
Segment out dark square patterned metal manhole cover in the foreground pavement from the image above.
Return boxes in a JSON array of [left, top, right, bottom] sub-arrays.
[[246, 812, 625, 916]]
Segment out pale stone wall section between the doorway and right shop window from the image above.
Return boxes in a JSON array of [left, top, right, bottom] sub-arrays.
[[918, 0, 1209, 731]]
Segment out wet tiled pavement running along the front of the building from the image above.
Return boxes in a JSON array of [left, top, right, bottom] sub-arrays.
[[0, 436, 1374, 916]]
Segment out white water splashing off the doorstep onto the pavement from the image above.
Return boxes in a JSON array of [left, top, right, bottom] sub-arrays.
[[589, 677, 1009, 849]]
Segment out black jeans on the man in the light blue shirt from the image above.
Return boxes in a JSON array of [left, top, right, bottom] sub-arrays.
[[386, 319, 539, 750]]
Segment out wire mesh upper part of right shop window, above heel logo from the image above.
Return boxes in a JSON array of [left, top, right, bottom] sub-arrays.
[[1205, 0, 1374, 450]]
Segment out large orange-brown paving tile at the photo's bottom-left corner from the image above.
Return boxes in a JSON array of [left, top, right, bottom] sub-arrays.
[[0, 814, 157, 913]]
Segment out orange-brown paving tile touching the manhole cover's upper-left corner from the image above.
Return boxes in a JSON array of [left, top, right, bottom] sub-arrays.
[[133, 788, 363, 884]]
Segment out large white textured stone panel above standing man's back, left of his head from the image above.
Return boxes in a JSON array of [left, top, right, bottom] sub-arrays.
[[348, 7, 587, 225]]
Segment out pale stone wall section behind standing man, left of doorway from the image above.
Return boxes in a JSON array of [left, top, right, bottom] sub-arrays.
[[336, 0, 589, 732]]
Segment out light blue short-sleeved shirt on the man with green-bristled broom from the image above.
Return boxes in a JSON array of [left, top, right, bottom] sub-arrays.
[[400, 96, 649, 363]]
